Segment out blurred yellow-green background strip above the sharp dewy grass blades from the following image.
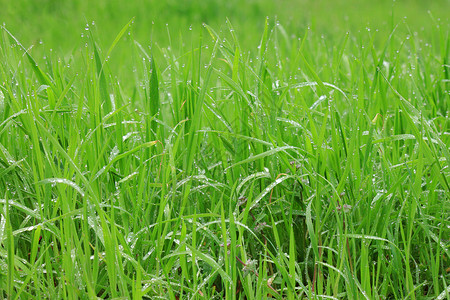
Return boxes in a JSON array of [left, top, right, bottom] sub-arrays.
[[0, 0, 450, 53]]
